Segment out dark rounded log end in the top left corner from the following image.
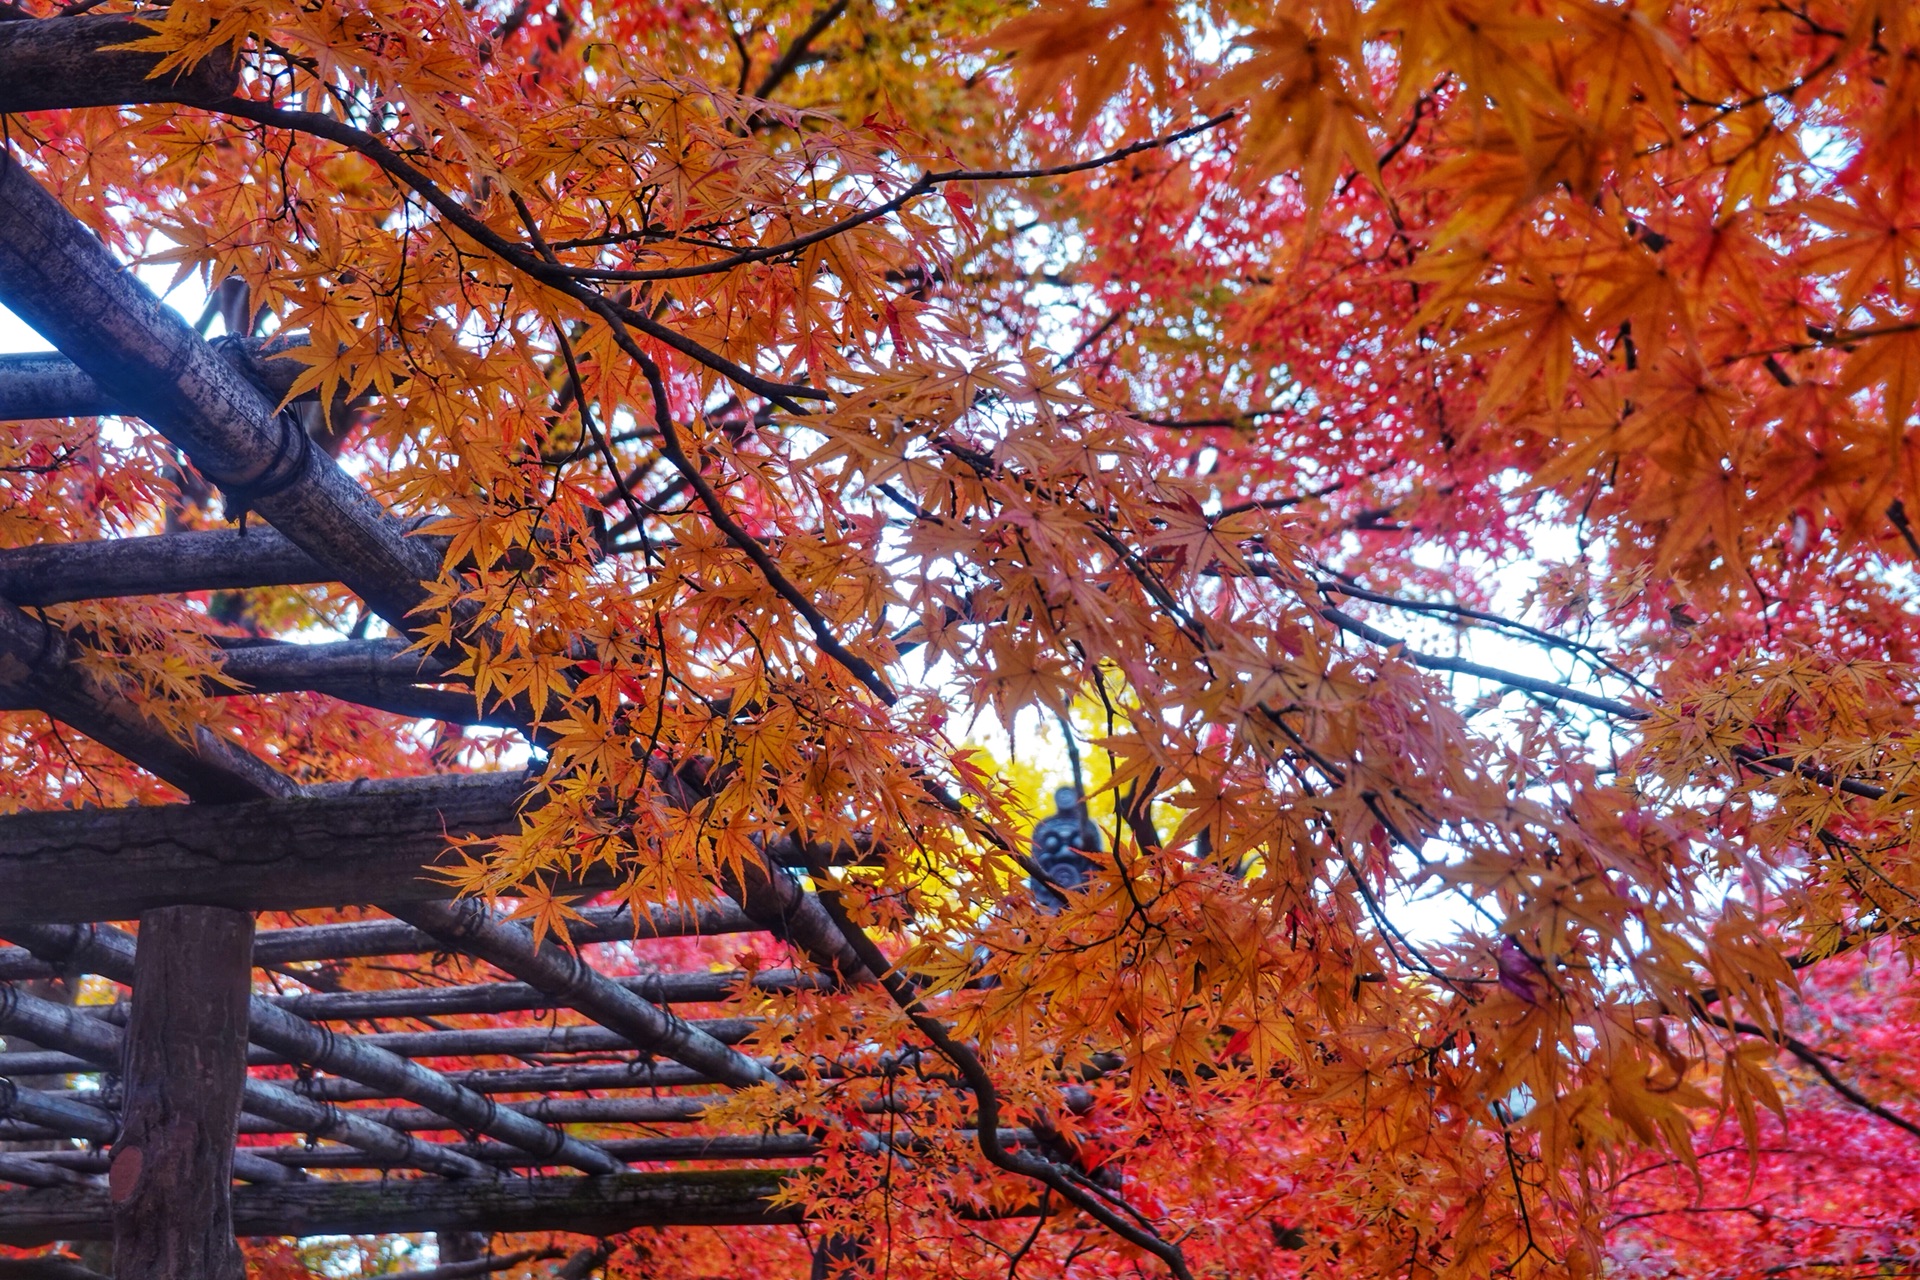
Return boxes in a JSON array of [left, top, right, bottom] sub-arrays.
[[0, 15, 240, 111]]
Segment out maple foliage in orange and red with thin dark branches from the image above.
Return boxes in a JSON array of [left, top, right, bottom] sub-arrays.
[[0, 0, 1920, 1276]]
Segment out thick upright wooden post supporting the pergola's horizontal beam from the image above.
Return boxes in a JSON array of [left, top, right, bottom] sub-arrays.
[[108, 906, 253, 1280]]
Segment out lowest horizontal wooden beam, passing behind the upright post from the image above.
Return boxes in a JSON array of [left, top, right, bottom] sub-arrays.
[[0, 1169, 801, 1247]]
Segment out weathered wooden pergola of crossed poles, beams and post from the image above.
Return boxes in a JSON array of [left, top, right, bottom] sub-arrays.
[[0, 17, 990, 1280]]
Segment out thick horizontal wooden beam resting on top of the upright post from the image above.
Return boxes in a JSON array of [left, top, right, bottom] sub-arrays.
[[0, 773, 526, 925]]
